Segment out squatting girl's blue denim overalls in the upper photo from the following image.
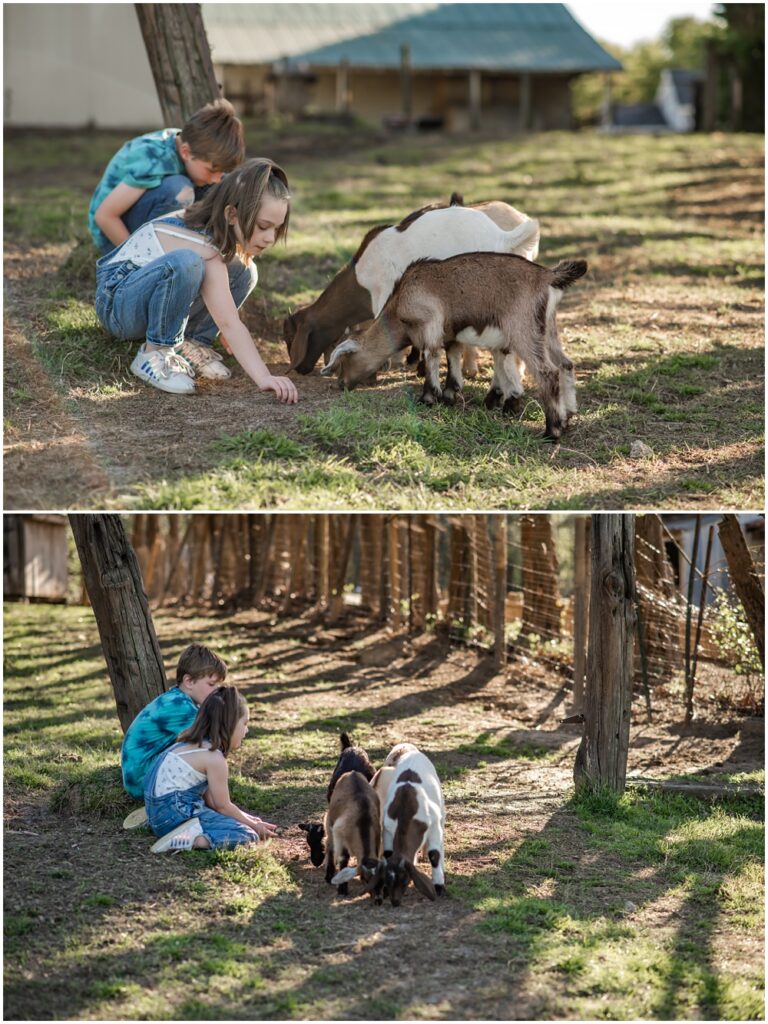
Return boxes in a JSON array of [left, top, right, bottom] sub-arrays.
[[96, 216, 258, 348]]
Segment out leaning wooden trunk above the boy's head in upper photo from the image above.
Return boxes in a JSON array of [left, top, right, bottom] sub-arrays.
[[135, 3, 221, 128]]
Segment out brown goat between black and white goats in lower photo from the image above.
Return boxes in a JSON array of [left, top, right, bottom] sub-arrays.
[[326, 771, 381, 903]]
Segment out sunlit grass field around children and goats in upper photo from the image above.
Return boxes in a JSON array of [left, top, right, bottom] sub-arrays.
[[5, 128, 764, 509]]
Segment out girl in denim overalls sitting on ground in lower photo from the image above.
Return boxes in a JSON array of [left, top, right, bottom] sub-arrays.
[[144, 686, 276, 853]]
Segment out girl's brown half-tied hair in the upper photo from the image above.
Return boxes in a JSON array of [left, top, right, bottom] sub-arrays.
[[184, 157, 291, 263]]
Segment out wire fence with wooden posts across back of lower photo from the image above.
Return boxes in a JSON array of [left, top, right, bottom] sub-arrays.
[[118, 513, 765, 711]]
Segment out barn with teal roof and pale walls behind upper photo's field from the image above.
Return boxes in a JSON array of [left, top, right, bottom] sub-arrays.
[[3, 3, 621, 133]]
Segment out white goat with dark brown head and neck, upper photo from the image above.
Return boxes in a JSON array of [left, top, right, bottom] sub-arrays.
[[284, 193, 539, 374]]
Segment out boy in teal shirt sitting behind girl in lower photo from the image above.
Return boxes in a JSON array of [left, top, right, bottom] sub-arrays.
[[120, 643, 226, 828]]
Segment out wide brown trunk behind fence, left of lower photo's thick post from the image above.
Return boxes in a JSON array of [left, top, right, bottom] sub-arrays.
[[520, 514, 560, 640]]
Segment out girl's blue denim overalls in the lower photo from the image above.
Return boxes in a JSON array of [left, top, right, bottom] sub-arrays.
[[144, 743, 259, 850]]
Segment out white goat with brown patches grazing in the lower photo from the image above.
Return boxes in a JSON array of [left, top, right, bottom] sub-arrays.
[[364, 743, 445, 906]]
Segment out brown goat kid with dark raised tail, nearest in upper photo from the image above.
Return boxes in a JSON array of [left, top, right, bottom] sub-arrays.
[[322, 252, 587, 440]]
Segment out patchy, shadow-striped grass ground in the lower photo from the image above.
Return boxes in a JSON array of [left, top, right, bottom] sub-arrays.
[[4, 605, 764, 1020]]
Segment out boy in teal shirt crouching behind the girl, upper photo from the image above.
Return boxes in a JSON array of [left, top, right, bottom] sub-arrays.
[[88, 99, 246, 256]]
